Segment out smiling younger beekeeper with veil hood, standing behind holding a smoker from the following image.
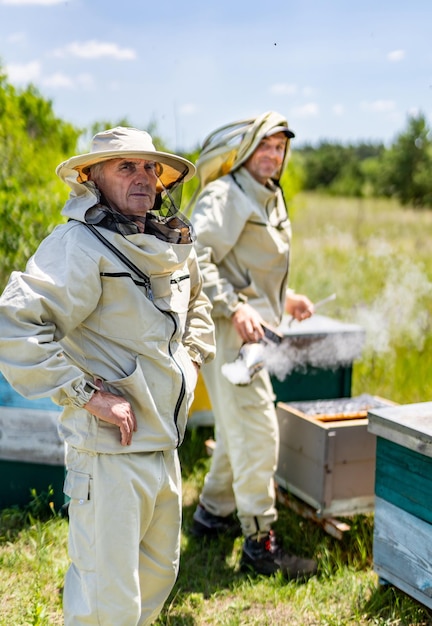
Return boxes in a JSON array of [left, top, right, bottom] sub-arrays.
[[191, 112, 316, 578]]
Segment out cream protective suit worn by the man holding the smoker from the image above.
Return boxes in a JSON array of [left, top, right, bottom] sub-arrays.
[[191, 167, 291, 536]]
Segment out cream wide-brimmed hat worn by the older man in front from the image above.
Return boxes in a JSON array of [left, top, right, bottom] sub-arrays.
[[56, 126, 195, 191]]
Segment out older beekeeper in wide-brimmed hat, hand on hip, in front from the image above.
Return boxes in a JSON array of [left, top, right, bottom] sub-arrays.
[[0, 127, 214, 626]]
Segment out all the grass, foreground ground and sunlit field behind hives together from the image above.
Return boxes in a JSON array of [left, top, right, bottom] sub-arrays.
[[0, 195, 432, 626]]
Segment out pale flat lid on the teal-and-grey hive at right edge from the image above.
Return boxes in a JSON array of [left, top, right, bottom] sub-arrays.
[[368, 402, 432, 457]]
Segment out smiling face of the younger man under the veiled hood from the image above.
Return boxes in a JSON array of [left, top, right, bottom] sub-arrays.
[[244, 133, 287, 185]]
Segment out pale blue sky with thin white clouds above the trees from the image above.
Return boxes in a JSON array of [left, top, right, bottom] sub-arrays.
[[0, 0, 432, 150]]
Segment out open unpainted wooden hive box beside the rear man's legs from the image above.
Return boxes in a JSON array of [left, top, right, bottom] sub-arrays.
[[276, 394, 390, 518]]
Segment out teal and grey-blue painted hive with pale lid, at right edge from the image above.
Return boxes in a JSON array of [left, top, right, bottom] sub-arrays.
[[369, 402, 432, 608]]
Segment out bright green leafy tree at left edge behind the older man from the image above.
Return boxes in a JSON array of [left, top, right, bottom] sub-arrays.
[[0, 72, 81, 285]]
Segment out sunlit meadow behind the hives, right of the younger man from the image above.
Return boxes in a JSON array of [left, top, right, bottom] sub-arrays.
[[291, 195, 432, 404]]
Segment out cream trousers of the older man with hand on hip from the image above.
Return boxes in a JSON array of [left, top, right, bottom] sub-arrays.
[[64, 448, 181, 626]]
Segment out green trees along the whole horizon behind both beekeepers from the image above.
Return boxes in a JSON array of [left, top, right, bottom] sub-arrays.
[[0, 69, 432, 288]]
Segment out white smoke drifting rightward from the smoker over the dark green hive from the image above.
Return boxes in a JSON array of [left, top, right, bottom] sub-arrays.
[[224, 251, 432, 384]]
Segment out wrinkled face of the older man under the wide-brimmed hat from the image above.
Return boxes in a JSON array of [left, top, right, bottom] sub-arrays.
[[90, 159, 159, 216]]
